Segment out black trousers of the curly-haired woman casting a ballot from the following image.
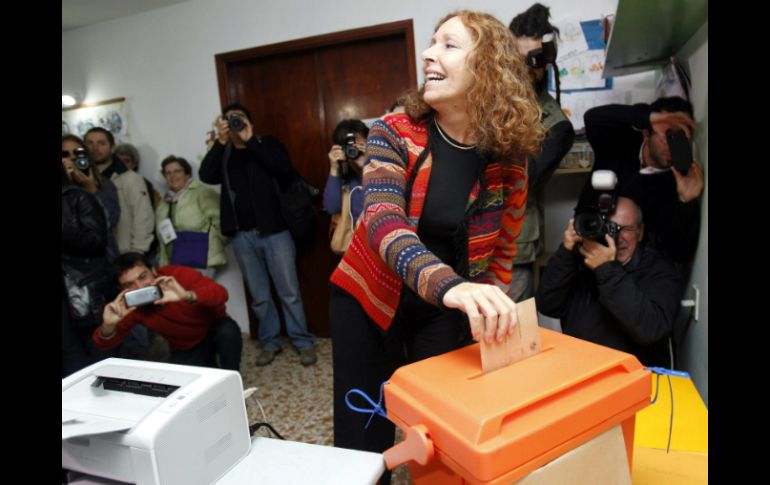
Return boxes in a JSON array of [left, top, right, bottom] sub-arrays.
[[329, 285, 472, 476]]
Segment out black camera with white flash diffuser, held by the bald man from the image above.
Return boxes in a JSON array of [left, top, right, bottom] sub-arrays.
[[575, 170, 620, 244]]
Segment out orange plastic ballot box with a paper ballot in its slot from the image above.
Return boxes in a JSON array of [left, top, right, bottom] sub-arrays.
[[384, 328, 651, 485]]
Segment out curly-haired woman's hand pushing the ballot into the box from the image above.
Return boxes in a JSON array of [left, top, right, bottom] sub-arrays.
[[443, 283, 519, 343]]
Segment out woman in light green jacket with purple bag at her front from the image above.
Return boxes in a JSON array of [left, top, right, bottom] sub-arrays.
[[155, 155, 227, 277]]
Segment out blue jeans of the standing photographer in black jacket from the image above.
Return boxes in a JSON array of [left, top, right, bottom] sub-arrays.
[[232, 229, 315, 351]]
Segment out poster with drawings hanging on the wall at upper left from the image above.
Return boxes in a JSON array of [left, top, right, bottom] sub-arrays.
[[62, 98, 130, 144]]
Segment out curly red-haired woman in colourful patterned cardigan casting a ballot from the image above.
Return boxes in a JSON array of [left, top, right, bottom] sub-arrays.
[[330, 11, 544, 474]]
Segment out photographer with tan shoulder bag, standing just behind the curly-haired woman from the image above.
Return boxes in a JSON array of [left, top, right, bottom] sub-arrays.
[[323, 119, 369, 254]]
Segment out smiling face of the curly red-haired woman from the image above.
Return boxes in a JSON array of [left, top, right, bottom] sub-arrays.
[[422, 17, 473, 112]]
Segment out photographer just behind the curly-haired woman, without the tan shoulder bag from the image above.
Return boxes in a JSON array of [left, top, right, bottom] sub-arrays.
[[323, 120, 369, 224]]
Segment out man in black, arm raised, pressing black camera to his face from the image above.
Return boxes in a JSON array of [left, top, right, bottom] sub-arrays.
[[578, 97, 703, 264]]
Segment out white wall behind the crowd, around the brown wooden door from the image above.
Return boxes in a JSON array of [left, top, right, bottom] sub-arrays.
[[62, 0, 632, 331]]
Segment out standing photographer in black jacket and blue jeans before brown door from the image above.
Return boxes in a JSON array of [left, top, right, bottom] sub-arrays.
[[198, 103, 317, 366]]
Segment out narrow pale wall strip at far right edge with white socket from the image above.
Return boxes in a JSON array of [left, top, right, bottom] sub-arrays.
[[677, 21, 709, 406]]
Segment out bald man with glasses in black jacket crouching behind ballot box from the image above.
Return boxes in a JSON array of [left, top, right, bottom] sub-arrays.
[[535, 197, 682, 366]]
